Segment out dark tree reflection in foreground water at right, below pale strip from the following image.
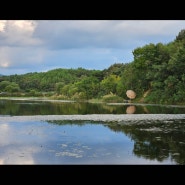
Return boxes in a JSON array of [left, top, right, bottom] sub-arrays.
[[109, 120, 185, 164]]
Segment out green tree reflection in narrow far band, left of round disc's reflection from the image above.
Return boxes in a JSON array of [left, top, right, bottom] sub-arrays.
[[0, 100, 126, 115]]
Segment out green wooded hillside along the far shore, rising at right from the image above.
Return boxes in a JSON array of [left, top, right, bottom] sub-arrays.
[[0, 30, 185, 104]]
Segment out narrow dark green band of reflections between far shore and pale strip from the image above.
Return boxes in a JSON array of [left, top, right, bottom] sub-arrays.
[[0, 100, 185, 115]]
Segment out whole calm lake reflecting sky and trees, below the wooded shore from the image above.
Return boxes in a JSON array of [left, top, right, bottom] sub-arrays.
[[0, 98, 185, 165]]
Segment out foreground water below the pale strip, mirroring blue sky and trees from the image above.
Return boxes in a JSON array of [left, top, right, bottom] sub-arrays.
[[0, 120, 185, 165]]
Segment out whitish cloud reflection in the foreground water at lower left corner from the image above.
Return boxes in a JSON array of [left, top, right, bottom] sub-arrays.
[[0, 122, 43, 164]]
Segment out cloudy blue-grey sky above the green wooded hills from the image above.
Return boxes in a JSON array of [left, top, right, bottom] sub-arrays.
[[0, 20, 185, 75]]
